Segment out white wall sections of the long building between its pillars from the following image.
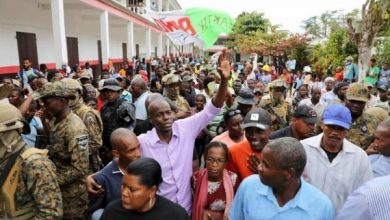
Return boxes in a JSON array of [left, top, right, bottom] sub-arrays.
[[0, 0, 171, 72]]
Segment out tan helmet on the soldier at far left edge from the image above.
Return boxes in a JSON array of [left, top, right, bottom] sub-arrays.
[[0, 103, 24, 132]]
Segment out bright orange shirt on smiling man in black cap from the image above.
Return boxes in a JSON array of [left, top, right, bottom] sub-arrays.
[[226, 140, 261, 180]]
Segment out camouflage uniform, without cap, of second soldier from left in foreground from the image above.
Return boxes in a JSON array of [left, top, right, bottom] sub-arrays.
[[49, 113, 89, 219]]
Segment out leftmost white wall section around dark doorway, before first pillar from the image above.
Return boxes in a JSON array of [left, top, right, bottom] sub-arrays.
[[0, 0, 54, 66]]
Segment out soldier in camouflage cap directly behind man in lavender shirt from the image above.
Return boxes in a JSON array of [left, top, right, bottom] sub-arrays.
[[162, 73, 191, 112]]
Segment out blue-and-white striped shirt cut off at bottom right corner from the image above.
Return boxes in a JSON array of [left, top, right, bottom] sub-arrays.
[[336, 175, 390, 220]]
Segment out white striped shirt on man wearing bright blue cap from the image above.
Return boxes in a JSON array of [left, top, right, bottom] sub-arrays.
[[301, 133, 373, 213]]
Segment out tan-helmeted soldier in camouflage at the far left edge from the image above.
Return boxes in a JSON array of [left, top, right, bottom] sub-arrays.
[[0, 103, 63, 220]]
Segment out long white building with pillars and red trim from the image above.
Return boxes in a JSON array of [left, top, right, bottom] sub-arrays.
[[0, 0, 192, 74]]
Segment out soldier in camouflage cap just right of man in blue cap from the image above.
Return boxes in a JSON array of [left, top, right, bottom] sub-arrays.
[[345, 83, 378, 150]]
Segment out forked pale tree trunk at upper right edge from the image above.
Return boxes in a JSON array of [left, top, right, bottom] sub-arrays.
[[347, 0, 390, 80]]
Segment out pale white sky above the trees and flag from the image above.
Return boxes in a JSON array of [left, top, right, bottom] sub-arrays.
[[177, 0, 365, 33]]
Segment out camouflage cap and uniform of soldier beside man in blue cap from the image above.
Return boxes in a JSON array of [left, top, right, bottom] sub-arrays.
[[346, 83, 378, 150]]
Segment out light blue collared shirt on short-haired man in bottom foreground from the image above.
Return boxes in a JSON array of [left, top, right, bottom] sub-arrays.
[[229, 174, 334, 220]]
